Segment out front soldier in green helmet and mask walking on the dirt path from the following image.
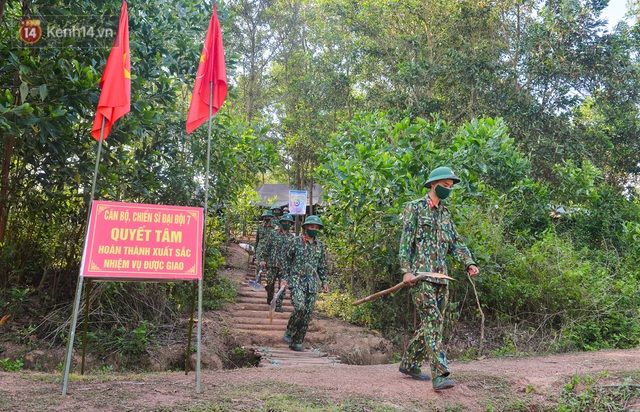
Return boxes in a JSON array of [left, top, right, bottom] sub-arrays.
[[399, 167, 479, 390]]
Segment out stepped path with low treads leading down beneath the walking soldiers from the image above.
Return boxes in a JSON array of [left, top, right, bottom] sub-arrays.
[[229, 262, 340, 367]]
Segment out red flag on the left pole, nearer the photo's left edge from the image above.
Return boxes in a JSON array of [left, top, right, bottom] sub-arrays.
[[91, 1, 131, 140]]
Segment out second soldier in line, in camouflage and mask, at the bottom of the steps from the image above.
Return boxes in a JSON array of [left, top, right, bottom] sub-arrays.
[[282, 215, 329, 351]]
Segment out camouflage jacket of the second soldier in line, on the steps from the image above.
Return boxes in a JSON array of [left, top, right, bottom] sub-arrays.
[[284, 236, 328, 293]]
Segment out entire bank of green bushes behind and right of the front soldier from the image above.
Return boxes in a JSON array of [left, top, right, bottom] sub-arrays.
[[317, 115, 640, 353]]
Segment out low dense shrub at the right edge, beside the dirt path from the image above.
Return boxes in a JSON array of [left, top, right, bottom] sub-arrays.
[[480, 232, 640, 350]]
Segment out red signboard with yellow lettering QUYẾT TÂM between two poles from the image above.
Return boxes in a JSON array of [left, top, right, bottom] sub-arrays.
[[82, 201, 203, 280]]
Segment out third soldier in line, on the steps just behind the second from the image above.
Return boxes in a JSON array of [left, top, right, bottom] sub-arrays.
[[260, 214, 295, 312]]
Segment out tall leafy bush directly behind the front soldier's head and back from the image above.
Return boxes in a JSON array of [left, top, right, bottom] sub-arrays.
[[316, 114, 532, 322]]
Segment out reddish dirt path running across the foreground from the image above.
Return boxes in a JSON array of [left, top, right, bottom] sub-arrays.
[[0, 243, 640, 412]]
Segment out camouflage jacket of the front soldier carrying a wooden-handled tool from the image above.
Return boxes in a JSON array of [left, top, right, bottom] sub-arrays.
[[398, 196, 475, 284]]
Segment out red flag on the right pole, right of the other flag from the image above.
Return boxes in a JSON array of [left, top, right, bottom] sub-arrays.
[[187, 4, 227, 133]]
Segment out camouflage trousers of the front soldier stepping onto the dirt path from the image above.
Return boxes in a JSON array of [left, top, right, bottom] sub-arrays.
[[400, 281, 449, 378]]
